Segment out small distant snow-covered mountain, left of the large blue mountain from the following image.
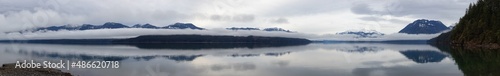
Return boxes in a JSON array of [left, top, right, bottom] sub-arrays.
[[337, 30, 385, 38]]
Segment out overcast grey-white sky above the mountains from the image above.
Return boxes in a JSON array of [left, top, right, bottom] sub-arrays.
[[0, 0, 476, 34]]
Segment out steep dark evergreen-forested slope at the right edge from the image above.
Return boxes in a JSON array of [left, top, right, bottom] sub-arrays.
[[430, 0, 500, 49]]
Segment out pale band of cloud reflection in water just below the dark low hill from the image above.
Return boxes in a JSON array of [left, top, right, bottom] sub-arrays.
[[0, 43, 310, 56]]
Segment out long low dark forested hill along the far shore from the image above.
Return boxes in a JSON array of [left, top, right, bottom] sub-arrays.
[[112, 35, 311, 44]]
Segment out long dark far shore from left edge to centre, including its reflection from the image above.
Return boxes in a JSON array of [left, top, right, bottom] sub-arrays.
[[0, 35, 311, 49]]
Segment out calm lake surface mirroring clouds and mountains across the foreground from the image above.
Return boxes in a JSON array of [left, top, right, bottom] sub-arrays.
[[0, 43, 500, 76]]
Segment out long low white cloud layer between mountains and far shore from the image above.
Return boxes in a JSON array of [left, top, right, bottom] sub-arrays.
[[0, 28, 446, 41]]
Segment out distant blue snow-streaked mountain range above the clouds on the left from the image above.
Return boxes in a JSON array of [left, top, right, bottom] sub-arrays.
[[6, 22, 204, 33]]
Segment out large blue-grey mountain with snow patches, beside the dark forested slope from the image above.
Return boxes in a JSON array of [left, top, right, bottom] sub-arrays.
[[399, 19, 448, 34]]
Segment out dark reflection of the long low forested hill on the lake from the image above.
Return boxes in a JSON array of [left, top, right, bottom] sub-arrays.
[[0, 39, 309, 50]]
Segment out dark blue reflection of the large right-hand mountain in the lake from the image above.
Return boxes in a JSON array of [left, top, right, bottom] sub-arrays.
[[400, 50, 446, 63]]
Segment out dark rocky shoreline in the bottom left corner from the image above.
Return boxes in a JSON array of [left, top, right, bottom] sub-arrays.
[[0, 63, 73, 76]]
